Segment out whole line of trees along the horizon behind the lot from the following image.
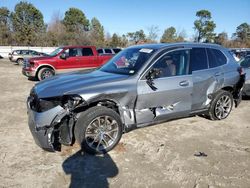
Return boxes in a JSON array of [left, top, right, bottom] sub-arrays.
[[0, 1, 250, 47]]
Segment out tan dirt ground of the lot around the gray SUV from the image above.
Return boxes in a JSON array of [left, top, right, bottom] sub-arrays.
[[0, 60, 250, 188]]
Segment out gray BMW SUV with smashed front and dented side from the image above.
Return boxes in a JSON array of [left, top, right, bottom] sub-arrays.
[[27, 43, 245, 154]]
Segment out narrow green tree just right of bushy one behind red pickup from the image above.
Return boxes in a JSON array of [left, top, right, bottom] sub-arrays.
[[90, 17, 105, 47]]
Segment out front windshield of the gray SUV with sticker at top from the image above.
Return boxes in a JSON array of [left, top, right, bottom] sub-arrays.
[[100, 48, 155, 75]]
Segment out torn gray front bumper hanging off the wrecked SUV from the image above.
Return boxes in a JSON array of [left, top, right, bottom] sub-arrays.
[[27, 99, 67, 151]]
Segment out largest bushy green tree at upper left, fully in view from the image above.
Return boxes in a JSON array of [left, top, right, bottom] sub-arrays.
[[11, 1, 46, 46]]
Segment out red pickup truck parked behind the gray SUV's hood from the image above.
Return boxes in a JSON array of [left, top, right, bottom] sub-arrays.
[[22, 46, 112, 80]]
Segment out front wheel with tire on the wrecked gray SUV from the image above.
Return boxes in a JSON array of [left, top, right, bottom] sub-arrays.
[[75, 106, 122, 154]]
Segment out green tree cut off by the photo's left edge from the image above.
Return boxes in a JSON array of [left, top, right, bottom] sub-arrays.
[[0, 7, 11, 45]]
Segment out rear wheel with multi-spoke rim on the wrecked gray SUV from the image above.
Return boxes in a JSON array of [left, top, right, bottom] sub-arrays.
[[208, 90, 233, 120]]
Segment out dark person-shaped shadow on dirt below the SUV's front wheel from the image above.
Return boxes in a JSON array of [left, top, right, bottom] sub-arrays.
[[62, 151, 119, 188]]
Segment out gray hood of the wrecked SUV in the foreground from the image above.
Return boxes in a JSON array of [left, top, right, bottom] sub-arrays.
[[35, 70, 128, 98]]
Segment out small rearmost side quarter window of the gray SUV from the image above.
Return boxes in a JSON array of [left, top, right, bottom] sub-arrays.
[[207, 48, 227, 68]]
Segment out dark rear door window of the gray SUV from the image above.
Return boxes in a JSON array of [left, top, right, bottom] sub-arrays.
[[190, 48, 208, 73]]
